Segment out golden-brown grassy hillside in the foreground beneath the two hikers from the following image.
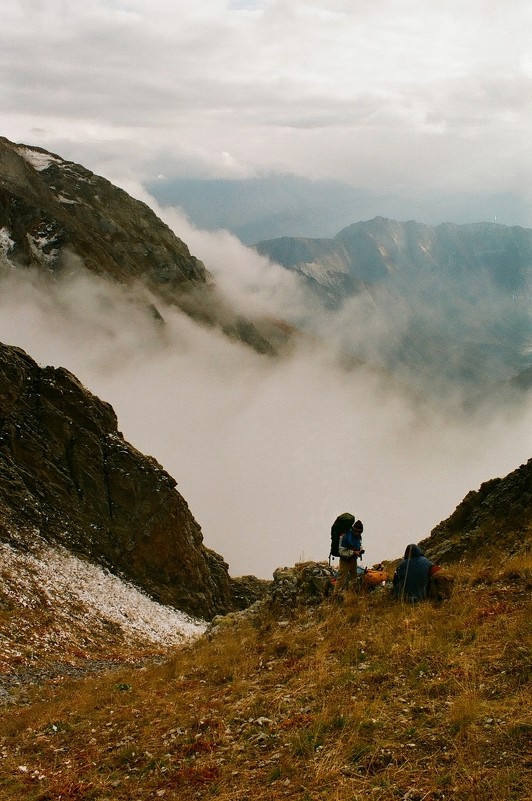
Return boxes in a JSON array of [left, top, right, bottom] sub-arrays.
[[0, 554, 532, 801]]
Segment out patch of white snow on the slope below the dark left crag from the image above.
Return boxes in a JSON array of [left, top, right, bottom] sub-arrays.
[[0, 543, 207, 646]]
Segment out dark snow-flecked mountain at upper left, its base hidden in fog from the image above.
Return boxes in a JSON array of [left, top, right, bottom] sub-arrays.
[[0, 137, 275, 355]]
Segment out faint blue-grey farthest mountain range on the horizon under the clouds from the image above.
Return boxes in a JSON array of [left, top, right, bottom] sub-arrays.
[[146, 173, 532, 245]]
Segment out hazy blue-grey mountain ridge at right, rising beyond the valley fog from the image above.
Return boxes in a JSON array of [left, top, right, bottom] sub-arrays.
[[255, 212, 532, 386]]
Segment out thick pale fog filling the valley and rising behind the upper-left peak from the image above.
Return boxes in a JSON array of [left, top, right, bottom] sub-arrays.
[[0, 208, 532, 578]]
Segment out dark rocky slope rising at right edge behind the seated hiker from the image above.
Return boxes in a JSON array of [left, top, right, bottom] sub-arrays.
[[419, 459, 532, 563]]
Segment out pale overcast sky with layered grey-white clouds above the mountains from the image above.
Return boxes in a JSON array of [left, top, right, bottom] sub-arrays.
[[4, 0, 532, 203]]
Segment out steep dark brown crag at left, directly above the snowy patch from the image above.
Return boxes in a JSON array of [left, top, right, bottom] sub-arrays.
[[0, 345, 234, 618]]
